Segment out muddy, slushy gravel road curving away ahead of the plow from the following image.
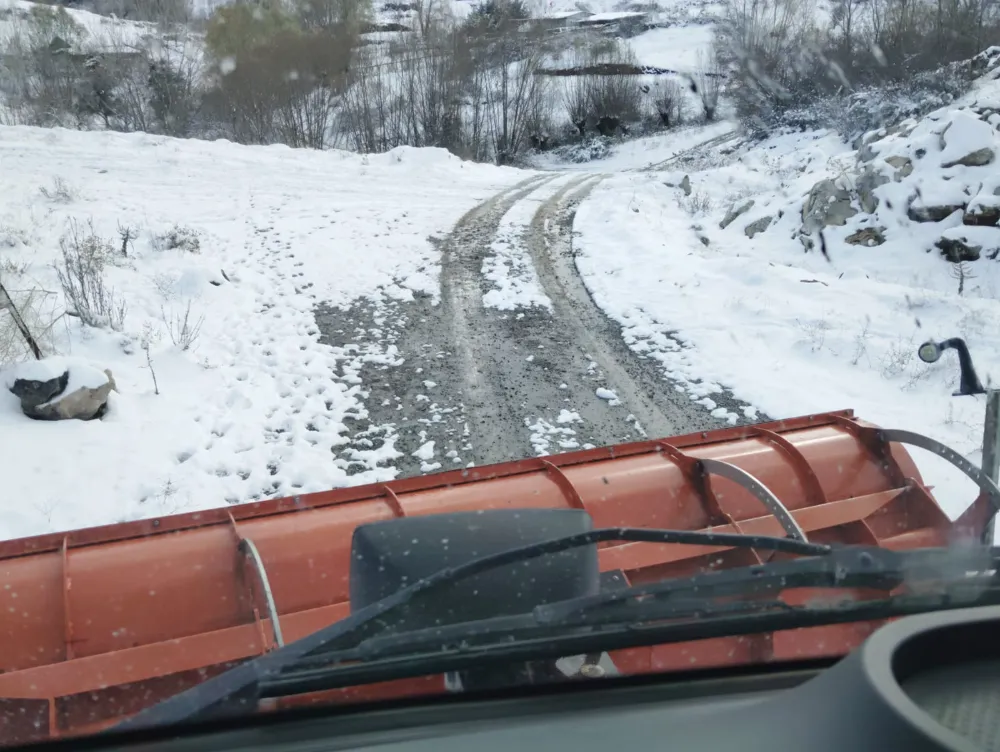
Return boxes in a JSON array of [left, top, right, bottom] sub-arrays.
[[317, 166, 756, 477]]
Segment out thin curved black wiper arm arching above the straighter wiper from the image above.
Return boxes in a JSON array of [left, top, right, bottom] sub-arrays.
[[109, 528, 833, 731]]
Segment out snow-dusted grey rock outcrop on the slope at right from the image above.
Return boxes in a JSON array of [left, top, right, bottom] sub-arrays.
[[733, 47, 1000, 263]]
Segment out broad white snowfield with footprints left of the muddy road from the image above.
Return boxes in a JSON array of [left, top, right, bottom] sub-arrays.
[[0, 127, 524, 538]]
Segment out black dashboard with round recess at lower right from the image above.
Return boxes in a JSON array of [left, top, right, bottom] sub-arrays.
[[17, 607, 1000, 752]]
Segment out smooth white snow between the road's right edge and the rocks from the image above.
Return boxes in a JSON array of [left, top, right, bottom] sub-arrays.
[[575, 159, 1000, 515]]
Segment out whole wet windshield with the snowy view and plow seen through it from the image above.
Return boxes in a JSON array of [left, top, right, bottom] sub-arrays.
[[0, 0, 1000, 746]]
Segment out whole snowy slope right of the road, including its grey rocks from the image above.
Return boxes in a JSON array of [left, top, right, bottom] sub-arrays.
[[575, 50, 1000, 514]]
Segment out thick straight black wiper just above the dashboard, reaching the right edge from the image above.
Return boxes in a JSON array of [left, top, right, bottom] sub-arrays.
[[259, 547, 1000, 697]]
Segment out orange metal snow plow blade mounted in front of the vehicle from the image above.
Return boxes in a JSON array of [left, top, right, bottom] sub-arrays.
[[0, 411, 989, 744]]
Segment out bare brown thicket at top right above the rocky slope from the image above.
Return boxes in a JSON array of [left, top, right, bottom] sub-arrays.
[[716, 0, 1000, 131]]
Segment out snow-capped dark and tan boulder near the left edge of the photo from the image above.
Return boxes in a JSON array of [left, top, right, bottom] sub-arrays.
[[8, 358, 117, 420]]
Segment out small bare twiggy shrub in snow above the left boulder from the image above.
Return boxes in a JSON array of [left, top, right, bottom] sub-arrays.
[[56, 221, 127, 332]]
